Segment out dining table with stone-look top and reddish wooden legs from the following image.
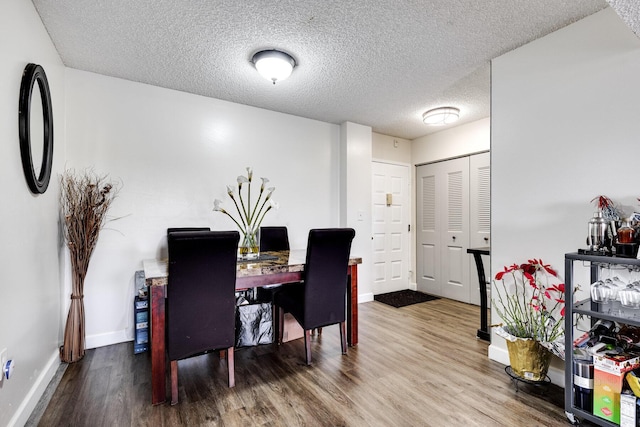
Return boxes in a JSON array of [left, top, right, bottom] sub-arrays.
[[142, 249, 362, 405]]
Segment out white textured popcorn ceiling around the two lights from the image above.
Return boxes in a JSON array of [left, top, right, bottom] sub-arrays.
[[33, 0, 620, 139]]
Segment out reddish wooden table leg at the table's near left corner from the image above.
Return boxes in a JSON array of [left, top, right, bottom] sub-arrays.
[[151, 286, 167, 405]]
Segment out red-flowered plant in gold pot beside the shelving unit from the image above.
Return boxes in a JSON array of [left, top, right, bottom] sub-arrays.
[[493, 259, 565, 381]]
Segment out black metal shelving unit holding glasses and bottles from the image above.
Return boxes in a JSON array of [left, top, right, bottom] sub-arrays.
[[564, 252, 640, 427]]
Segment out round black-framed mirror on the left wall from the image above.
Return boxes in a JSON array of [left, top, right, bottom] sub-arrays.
[[18, 64, 53, 194]]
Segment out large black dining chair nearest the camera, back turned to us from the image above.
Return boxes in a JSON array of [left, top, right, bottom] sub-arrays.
[[166, 231, 240, 405]]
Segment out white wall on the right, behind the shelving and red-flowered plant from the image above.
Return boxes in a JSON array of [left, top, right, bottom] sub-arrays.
[[489, 8, 640, 383]]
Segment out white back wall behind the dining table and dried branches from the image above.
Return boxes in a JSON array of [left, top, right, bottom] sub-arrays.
[[66, 69, 371, 348]]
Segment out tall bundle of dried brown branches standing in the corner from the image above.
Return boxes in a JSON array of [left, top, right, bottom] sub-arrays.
[[60, 170, 119, 363]]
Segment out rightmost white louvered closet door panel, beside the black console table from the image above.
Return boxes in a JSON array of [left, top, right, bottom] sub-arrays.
[[469, 153, 491, 305]]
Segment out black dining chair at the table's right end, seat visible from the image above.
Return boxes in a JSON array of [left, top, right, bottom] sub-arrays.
[[274, 228, 355, 365]]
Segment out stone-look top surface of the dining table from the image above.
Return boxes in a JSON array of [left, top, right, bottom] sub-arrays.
[[142, 249, 362, 286]]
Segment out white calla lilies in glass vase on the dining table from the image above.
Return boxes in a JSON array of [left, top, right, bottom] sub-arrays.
[[213, 167, 277, 259]]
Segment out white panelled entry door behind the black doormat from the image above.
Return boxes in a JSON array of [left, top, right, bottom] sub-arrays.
[[372, 162, 410, 295]]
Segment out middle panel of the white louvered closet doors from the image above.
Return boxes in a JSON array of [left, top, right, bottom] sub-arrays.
[[438, 157, 470, 302]]
